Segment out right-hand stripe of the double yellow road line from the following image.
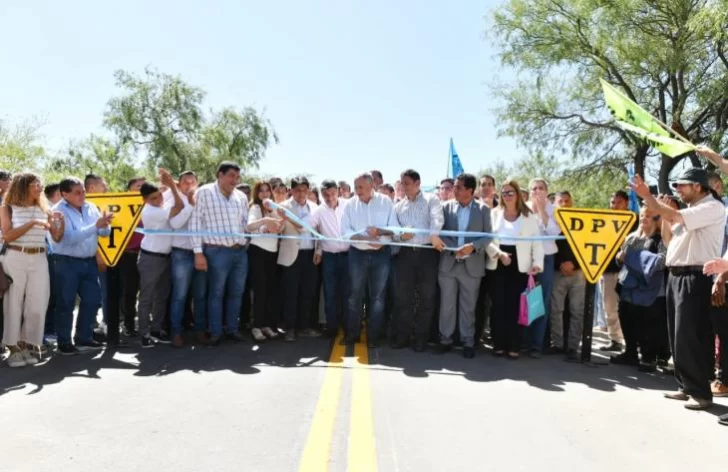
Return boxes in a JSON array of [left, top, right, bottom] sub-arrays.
[[347, 330, 377, 472]]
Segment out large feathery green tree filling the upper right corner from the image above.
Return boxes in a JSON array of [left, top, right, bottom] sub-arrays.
[[492, 0, 728, 192]]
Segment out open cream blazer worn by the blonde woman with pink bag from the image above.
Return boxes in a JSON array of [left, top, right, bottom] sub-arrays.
[[485, 207, 544, 274]]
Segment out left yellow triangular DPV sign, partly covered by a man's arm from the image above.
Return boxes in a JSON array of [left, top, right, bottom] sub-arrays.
[[86, 192, 144, 267]]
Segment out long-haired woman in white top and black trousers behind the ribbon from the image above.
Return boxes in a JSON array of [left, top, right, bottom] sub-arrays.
[[248, 182, 283, 342]]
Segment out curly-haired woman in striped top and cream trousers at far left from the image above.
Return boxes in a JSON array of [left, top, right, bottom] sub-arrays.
[[0, 172, 64, 367]]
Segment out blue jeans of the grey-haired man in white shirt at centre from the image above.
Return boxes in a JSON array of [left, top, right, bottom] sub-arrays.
[[346, 246, 392, 342]]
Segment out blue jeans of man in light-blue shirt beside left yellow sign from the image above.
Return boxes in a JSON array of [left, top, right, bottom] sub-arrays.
[[53, 255, 101, 345]]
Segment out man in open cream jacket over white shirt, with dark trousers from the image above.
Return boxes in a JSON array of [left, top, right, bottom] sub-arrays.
[[278, 176, 321, 342]]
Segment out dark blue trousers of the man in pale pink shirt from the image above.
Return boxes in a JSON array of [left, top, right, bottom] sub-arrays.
[[322, 252, 349, 329]]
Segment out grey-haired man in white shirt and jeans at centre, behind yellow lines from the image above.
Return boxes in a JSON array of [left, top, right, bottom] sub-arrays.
[[341, 173, 396, 348]]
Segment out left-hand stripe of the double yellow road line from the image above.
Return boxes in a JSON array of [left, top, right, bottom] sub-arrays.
[[298, 332, 346, 472]]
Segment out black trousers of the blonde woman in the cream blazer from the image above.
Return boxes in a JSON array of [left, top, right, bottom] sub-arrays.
[[486, 246, 528, 352]]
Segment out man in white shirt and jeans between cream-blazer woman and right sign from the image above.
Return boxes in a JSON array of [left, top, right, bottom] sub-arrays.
[[526, 178, 561, 358]]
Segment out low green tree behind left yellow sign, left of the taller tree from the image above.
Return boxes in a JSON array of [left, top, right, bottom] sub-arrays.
[[45, 135, 144, 192]]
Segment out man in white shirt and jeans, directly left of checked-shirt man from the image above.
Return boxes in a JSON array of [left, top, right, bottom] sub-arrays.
[[164, 171, 202, 347]]
